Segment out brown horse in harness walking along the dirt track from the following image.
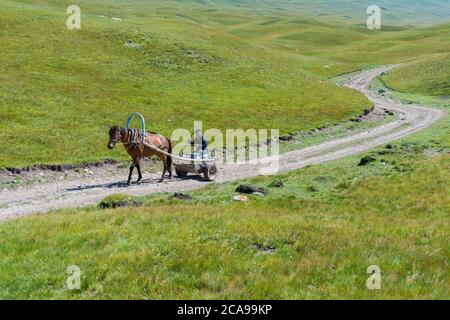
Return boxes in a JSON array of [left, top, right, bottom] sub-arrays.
[[108, 126, 172, 185]]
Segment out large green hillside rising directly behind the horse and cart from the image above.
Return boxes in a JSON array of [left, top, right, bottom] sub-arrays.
[[0, 1, 369, 167]]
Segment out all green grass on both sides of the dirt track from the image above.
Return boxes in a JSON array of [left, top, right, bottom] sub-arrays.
[[0, 0, 450, 299]]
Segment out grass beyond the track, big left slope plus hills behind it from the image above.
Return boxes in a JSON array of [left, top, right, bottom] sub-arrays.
[[0, 0, 450, 167]]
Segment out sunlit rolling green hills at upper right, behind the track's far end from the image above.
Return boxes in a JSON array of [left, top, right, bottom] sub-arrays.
[[228, 17, 450, 77]]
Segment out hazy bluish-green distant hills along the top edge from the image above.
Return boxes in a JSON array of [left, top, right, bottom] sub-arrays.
[[77, 0, 450, 26]]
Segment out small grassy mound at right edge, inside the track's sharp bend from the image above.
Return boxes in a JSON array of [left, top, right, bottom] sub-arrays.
[[383, 54, 450, 96]]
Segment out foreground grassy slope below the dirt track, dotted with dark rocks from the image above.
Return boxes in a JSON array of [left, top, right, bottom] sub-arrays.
[[0, 116, 450, 299]]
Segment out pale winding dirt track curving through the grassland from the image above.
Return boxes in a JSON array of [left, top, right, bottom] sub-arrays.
[[0, 68, 445, 219]]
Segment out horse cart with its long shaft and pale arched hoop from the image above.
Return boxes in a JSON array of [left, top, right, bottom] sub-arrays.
[[125, 112, 217, 181]]
